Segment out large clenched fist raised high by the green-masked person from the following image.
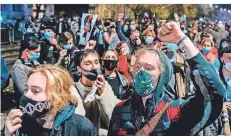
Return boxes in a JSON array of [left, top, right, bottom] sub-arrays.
[[158, 22, 185, 44]]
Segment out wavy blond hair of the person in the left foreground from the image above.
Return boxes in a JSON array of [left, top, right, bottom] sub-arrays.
[[28, 64, 77, 117]]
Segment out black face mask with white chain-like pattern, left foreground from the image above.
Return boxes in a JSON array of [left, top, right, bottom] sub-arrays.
[[19, 95, 49, 119]]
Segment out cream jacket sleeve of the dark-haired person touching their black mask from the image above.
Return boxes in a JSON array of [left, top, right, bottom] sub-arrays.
[[96, 81, 121, 120]]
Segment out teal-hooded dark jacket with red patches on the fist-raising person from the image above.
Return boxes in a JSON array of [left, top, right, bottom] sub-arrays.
[[108, 48, 226, 136]]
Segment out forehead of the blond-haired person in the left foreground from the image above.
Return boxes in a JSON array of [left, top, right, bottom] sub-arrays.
[[27, 72, 47, 90]]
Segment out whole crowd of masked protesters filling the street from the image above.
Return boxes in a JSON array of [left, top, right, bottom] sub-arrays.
[[1, 13, 231, 136]]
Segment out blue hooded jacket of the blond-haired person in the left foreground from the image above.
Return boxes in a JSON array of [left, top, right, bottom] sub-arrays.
[[2, 104, 98, 136]]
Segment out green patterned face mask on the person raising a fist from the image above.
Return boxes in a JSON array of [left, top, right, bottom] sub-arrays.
[[133, 68, 156, 97]]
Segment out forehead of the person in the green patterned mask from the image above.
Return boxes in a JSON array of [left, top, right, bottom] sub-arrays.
[[136, 52, 159, 66]]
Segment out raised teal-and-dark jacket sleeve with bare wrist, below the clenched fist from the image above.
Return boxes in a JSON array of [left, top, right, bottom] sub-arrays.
[[169, 38, 226, 135]]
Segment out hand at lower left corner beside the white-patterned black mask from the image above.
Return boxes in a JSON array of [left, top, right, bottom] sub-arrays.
[[5, 109, 23, 136]]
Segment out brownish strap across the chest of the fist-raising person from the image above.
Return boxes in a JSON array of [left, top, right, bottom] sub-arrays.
[[136, 102, 172, 136]]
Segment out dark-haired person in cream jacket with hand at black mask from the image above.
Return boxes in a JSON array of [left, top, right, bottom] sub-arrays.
[[75, 49, 119, 134]]
